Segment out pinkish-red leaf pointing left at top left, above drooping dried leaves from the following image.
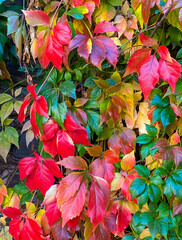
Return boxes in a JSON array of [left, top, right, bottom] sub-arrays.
[[22, 10, 50, 27]]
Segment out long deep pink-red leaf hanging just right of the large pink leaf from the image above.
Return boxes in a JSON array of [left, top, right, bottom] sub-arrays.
[[87, 177, 110, 228]]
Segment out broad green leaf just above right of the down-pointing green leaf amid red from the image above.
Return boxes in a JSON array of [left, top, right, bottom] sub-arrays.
[[59, 81, 76, 99]]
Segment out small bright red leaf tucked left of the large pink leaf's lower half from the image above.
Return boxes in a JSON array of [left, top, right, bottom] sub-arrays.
[[45, 202, 61, 227]]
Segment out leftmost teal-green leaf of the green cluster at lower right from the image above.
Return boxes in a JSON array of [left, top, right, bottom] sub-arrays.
[[129, 178, 146, 199]]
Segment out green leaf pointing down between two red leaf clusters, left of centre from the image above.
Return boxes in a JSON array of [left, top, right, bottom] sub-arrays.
[[51, 102, 68, 128]]
